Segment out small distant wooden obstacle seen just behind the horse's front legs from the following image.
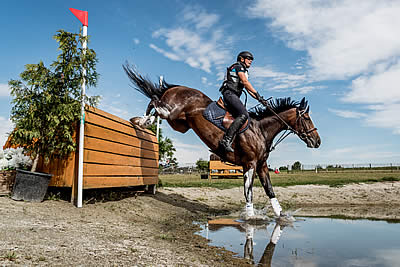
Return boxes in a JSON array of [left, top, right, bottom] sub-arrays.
[[208, 154, 243, 179]]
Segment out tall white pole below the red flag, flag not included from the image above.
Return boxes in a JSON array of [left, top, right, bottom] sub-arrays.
[[77, 25, 87, 208]]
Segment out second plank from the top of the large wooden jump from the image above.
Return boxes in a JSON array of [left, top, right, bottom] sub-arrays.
[[85, 123, 158, 151]]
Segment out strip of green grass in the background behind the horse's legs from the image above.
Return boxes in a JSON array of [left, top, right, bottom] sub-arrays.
[[159, 171, 400, 189]]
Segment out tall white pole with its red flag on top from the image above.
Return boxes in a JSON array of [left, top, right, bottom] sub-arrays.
[[69, 8, 88, 208]]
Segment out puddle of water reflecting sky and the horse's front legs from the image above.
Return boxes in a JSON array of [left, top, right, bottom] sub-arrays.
[[198, 217, 400, 266]]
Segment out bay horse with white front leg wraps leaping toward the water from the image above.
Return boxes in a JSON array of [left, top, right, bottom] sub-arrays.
[[123, 63, 321, 217]]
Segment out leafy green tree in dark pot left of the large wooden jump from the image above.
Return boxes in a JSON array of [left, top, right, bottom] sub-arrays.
[[8, 30, 99, 171]]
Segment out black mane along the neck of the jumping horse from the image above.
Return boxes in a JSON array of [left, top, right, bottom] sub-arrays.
[[249, 97, 299, 120]]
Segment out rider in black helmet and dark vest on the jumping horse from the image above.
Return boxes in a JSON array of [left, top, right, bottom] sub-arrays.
[[219, 51, 264, 152]]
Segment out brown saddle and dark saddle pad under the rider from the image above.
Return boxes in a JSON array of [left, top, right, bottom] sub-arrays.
[[203, 97, 250, 133]]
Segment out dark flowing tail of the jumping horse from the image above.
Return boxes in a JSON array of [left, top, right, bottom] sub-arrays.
[[122, 63, 177, 100]]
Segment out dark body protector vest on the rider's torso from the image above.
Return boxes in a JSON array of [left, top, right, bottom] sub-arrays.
[[219, 62, 249, 97]]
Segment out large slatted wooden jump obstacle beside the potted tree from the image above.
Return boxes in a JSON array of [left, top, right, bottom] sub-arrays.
[[4, 107, 158, 198]]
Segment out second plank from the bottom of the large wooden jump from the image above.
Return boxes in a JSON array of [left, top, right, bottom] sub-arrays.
[[83, 163, 158, 176]]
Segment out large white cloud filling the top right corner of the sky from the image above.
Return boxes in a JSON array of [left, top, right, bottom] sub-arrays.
[[249, 0, 400, 79]]
